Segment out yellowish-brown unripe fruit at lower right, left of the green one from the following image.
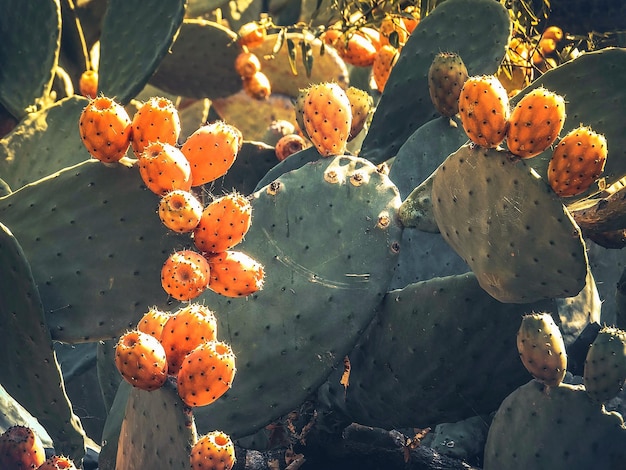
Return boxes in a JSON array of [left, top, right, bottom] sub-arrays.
[[517, 313, 567, 387]]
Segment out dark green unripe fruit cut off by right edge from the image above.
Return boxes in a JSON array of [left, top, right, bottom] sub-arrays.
[[583, 326, 626, 402]]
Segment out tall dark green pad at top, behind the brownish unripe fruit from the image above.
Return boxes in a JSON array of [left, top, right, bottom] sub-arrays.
[[360, 0, 511, 163]]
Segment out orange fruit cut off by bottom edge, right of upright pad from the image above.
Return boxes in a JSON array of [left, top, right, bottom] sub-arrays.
[[189, 431, 235, 470]]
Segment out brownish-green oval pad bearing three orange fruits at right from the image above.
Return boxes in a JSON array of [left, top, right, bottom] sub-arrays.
[[432, 144, 587, 302]]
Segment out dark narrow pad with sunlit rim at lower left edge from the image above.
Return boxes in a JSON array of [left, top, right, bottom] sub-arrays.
[[0, 224, 86, 461]]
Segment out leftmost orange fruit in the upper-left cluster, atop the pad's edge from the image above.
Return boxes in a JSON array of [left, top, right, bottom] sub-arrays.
[[78, 96, 131, 163]]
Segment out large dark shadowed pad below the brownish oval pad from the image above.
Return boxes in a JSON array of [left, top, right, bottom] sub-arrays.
[[325, 273, 555, 429]]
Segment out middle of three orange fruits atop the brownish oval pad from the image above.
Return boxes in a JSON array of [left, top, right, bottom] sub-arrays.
[[506, 87, 565, 158]]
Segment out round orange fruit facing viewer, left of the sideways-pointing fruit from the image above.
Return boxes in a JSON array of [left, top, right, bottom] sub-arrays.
[[161, 250, 211, 301]]
